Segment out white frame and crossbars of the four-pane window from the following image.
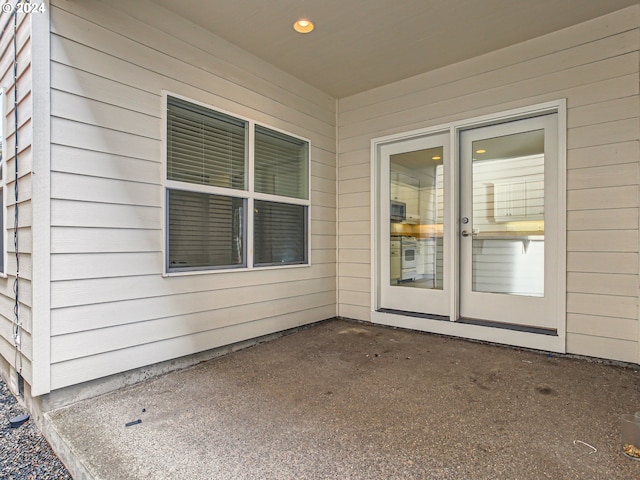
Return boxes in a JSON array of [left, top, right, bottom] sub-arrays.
[[161, 90, 311, 277]]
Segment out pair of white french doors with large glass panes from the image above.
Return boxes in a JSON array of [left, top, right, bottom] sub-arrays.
[[374, 113, 561, 333]]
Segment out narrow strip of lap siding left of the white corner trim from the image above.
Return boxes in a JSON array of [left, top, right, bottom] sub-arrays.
[[0, 8, 34, 383]]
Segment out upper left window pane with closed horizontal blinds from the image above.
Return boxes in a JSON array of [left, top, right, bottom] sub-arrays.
[[167, 97, 248, 189]]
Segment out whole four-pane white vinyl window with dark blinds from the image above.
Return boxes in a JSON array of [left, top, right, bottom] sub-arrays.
[[165, 96, 309, 273]]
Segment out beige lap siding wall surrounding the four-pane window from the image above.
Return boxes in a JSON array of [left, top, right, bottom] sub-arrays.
[[47, 0, 336, 389]]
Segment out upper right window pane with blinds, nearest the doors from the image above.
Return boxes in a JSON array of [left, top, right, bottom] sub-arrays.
[[255, 125, 309, 199]]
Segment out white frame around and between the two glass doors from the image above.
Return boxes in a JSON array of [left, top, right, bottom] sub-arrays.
[[371, 99, 567, 353]]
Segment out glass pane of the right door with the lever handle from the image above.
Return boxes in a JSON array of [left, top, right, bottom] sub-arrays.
[[467, 129, 544, 297]]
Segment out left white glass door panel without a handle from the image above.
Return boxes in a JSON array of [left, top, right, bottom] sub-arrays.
[[377, 133, 451, 315]]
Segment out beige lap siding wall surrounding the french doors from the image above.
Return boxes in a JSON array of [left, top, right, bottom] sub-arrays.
[[338, 6, 640, 362]]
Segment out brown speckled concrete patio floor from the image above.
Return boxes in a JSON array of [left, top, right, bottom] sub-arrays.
[[46, 320, 640, 480]]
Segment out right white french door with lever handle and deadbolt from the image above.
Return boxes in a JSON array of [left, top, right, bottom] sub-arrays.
[[459, 114, 558, 329]]
